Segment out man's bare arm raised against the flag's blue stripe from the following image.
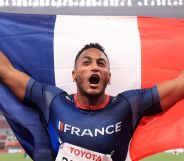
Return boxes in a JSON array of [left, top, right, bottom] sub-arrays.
[[0, 51, 30, 100]]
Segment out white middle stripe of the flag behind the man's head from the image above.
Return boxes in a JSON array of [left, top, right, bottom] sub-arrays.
[[54, 16, 141, 161]]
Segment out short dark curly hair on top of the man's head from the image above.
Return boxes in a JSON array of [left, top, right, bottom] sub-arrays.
[[75, 43, 109, 65]]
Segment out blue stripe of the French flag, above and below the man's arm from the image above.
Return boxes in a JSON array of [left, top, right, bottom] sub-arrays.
[[0, 14, 55, 161]]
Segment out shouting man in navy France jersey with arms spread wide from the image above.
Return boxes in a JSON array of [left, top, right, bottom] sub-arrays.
[[0, 43, 184, 161]]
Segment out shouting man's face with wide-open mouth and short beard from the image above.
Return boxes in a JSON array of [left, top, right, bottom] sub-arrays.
[[72, 48, 111, 96]]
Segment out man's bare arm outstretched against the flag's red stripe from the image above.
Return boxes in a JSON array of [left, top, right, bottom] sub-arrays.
[[157, 71, 184, 111]]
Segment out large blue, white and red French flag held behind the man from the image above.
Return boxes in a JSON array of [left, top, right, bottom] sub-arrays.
[[0, 13, 184, 161]]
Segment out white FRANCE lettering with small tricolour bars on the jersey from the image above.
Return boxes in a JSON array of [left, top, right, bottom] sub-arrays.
[[58, 121, 122, 137]]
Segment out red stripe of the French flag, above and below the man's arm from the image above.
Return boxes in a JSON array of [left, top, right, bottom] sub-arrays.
[[130, 17, 184, 161]]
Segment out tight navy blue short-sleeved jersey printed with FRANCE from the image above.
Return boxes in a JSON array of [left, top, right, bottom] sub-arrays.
[[25, 79, 161, 161]]
